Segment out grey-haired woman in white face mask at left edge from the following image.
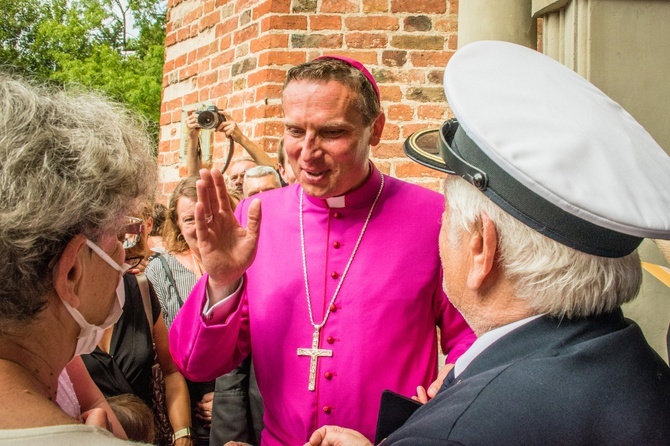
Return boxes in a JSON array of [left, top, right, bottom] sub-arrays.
[[0, 74, 156, 446]]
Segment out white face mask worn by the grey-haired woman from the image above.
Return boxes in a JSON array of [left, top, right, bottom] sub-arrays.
[[61, 240, 130, 356]]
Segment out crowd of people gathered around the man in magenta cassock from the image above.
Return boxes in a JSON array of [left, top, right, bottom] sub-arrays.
[[0, 38, 670, 446]]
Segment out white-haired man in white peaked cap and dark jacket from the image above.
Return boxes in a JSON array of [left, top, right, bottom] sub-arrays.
[[310, 42, 670, 445]]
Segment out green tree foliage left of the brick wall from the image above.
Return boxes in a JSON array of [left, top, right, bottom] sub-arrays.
[[0, 0, 166, 138]]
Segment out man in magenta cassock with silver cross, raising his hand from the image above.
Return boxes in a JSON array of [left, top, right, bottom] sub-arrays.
[[170, 56, 474, 445]]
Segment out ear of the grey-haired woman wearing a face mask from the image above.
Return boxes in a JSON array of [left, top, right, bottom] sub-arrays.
[[52, 235, 86, 308]]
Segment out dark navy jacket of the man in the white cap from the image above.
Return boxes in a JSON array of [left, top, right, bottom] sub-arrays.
[[384, 310, 670, 446]]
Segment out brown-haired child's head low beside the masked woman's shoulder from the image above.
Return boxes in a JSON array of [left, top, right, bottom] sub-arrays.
[[107, 393, 154, 443]]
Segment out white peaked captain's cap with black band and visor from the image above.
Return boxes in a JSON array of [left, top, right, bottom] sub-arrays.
[[405, 41, 670, 257]]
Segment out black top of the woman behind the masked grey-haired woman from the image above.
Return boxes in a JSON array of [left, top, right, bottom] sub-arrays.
[[82, 274, 161, 406]]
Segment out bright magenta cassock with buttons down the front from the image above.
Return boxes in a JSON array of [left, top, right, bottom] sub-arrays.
[[170, 168, 475, 445]]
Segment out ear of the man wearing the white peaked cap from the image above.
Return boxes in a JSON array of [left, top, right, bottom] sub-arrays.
[[467, 211, 498, 289]]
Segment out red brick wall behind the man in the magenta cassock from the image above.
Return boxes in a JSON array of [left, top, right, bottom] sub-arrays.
[[158, 0, 458, 201]]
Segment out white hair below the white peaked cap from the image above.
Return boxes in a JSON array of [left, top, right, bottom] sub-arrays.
[[445, 175, 642, 318]]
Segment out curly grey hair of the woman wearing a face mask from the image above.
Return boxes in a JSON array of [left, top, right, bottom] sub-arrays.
[[0, 73, 157, 326]]
